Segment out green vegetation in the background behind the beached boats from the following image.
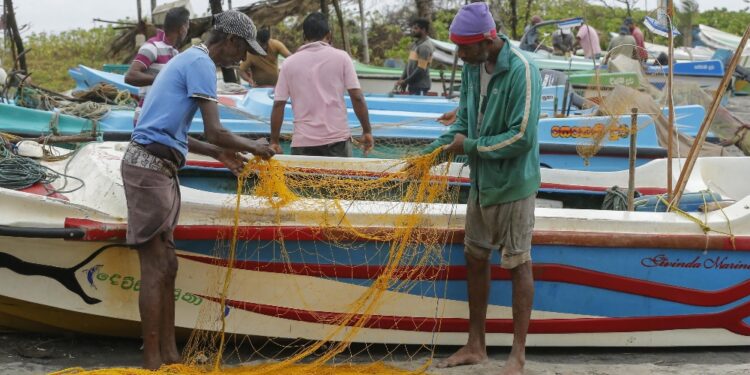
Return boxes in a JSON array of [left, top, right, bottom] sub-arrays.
[[2, 0, 750, 91]]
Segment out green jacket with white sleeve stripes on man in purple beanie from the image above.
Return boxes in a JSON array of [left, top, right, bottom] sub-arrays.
[[423, 35, 542, 207]]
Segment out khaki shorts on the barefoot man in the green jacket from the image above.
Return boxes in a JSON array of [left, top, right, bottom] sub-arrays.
[[464, 195, 536, 269]]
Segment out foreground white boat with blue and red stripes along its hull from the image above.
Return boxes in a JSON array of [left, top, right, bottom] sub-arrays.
[[0, 143, 750, 346]]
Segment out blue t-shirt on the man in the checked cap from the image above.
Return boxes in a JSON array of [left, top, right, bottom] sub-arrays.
[[130, 45, 217, 156]]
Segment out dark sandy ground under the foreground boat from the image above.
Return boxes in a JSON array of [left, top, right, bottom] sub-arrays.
[[0, 97, 750, 375]]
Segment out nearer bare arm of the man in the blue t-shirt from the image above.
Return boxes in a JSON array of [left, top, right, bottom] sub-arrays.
[[195, 98, 273, 159]]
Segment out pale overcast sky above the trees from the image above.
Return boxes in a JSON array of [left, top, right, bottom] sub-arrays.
[[14, 0, 747, 33]]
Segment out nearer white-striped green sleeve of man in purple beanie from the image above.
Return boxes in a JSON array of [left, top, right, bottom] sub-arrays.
[[462, 65, 542, 159]]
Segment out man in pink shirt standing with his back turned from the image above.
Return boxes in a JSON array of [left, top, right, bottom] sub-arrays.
[[271, 12, 374, 157]]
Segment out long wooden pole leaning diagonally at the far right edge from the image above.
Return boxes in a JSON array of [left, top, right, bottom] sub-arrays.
[[670, 25, 750, 209]]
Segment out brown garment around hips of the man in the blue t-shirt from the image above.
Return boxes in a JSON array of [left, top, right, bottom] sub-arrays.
[[120, 147, 180, 246]]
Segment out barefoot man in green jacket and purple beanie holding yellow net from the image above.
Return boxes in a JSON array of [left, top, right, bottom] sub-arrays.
[[424, 2, 542, 375]]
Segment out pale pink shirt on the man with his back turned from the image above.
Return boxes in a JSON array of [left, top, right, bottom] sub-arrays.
[[274, 42, 360, 147]]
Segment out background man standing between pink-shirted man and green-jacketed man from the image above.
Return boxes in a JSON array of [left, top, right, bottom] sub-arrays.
[[396, 18, 435, 95]]
